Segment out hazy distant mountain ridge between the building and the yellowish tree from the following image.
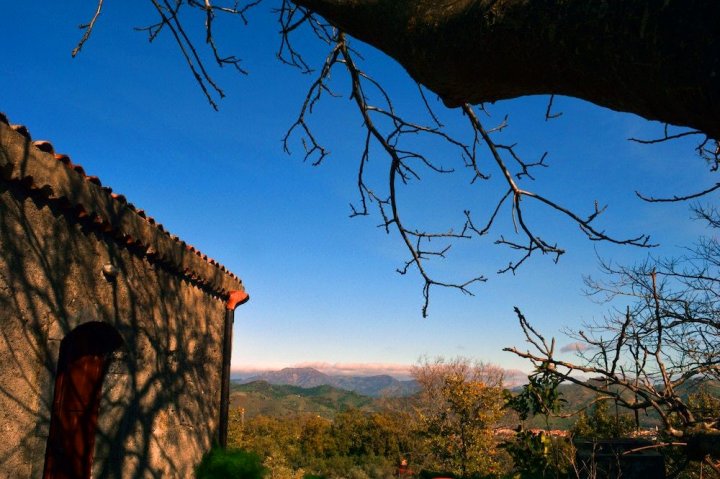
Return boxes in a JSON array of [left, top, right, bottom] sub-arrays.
[[233, 368, 420, 397]]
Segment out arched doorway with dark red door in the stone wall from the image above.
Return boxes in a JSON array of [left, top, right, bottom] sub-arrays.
[[43, 321, 122, 479]]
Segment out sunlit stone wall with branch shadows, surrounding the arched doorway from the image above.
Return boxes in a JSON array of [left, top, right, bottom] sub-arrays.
[[0, 118, 242, 478]]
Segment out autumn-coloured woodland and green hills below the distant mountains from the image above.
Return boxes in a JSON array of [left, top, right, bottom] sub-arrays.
[[219, 376, 720, 479]]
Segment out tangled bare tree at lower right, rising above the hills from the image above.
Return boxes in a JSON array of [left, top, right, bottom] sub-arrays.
[[506, 223, 720, 440]]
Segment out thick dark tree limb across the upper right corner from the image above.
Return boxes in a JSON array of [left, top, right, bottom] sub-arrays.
[[293, 0, 720, 138]]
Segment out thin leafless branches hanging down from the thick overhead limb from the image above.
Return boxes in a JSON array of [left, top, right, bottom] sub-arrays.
[[66, 0, 720, 316]]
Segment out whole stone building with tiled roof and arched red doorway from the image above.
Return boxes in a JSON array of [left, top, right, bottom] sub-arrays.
[[0, 114, 247, 478]]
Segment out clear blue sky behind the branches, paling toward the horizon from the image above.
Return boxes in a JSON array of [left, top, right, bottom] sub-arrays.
[[0, 0, 716, 378]]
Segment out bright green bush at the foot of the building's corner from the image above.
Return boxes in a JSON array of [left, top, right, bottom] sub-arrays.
[[195, 447, 267, 479]]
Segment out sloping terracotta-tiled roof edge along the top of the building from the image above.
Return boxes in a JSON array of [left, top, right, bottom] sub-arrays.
[[0, 113, 244, 296]]
